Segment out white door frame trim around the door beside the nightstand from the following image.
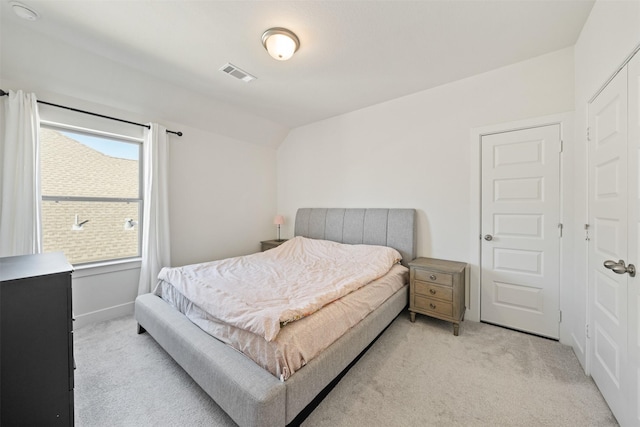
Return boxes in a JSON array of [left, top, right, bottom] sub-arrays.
[[465, 111, 586, 345]]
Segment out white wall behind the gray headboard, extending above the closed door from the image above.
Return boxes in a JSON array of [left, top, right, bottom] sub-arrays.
[[278, 48, 574, 326]]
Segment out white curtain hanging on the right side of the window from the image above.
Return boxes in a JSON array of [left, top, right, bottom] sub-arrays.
[[138, 123, 171, 295]]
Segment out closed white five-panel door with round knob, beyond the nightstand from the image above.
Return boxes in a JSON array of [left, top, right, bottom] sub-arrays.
[[480, 125, 562, 339]]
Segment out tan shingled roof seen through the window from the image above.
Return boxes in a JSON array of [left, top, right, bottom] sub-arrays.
[[41, 128, 140, 264]]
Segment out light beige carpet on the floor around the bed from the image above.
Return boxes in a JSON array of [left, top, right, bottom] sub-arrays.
[[74, 313, 617, 427]]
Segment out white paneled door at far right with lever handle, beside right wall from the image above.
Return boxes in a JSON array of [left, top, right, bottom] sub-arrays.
[[589, 61, 638, 425]]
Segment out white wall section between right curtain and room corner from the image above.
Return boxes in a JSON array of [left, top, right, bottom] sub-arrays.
[[169, 125, 276, 266]]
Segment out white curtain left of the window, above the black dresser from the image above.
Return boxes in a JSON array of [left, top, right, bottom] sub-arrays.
[[0, 90, 42, 256]]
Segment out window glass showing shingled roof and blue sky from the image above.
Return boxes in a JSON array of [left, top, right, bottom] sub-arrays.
[[40, 125, 142, 264]]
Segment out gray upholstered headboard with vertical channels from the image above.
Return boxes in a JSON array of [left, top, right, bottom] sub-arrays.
[[294, 208, 416, 266]]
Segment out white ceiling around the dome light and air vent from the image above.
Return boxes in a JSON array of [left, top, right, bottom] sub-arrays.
[[0, 0, 593, 145]]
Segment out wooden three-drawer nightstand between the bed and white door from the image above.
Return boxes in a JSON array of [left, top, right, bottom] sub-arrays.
[[409, 258, 467, 336]]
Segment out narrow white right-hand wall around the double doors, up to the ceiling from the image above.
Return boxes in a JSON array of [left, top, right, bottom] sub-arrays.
[[570, 0, 640, 368]]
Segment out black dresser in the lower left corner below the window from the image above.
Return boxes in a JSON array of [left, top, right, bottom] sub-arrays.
[[0, 252, 74, 427]]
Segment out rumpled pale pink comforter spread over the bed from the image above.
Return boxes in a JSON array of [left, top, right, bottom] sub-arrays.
[[158, 237, 400, 341]]
